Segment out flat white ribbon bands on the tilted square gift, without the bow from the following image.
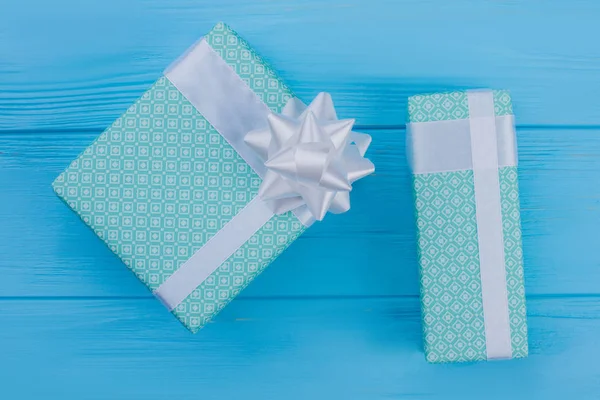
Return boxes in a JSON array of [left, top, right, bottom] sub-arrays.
[[154, 39, 314, 310]]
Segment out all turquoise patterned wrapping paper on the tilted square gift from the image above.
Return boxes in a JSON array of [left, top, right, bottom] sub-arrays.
[[53, 23, 306, 332]]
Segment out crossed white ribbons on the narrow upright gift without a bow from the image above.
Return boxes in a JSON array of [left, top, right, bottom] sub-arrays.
[[407, 90, 517, 359]]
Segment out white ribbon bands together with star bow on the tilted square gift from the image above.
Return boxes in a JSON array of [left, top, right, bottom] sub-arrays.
[[154, 39, 374, 310]]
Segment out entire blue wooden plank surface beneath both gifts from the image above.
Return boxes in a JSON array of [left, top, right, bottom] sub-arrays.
[[0, 0, 600, 399]]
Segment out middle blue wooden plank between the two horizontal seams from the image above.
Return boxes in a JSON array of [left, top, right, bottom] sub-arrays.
[[0, 129, 600, 297]]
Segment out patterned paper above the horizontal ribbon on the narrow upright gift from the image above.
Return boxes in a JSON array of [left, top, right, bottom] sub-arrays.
[[408, 90, 513, 122]]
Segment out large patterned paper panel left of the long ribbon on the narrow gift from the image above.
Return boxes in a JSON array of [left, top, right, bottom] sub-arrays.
[[413, 170, 486, 362]]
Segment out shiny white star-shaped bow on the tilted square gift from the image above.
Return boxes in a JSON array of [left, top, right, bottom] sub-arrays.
[[244, 93, 375, 221]]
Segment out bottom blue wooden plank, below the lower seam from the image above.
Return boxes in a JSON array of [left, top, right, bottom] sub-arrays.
[[0, 297, 600, 400]]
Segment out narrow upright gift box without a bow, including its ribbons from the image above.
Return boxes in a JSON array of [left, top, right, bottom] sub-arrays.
[[407, 90, 528, 363]]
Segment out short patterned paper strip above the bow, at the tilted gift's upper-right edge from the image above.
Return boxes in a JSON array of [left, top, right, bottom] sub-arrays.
[[205, 22, 294, 113]]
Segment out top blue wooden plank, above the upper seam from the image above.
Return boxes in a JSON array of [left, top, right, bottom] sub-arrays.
[[0, 0, 600, 130]]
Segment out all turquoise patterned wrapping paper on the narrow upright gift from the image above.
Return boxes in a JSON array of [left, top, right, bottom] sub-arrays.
[[408, 91, 528, 363]]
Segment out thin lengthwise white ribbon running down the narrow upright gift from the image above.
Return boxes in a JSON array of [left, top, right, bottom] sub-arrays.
[[467, 91, 512, 359]]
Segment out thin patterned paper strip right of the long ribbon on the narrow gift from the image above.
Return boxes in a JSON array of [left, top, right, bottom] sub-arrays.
[[499, 167, 528, 358]]
